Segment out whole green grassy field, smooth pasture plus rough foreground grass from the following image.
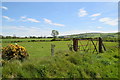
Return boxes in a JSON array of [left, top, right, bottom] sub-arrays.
[[2, 38, 120, 78]]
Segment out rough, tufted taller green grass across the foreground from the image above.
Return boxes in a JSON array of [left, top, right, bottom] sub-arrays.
[[3, 46, 120, 79]]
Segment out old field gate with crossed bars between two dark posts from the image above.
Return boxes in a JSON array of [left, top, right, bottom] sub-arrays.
[[73, 37, 106, 53]]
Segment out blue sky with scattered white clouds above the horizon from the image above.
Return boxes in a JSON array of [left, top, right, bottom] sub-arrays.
[[0, 2, 118, 36]]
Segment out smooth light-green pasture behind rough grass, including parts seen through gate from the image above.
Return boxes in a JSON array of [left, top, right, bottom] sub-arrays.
[[2, 39, 118, 57]]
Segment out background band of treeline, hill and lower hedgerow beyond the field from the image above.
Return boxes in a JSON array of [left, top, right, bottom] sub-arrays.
[[0, 33, 120, 43]]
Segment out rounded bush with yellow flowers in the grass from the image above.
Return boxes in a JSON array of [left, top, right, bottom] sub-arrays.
[[2, 44, 28, 60]]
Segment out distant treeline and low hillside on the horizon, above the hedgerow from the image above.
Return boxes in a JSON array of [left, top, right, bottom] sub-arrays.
[[0, 33, 120, 39]]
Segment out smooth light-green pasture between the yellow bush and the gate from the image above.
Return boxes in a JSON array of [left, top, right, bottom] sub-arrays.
[[2, 41, 71, 57]]
